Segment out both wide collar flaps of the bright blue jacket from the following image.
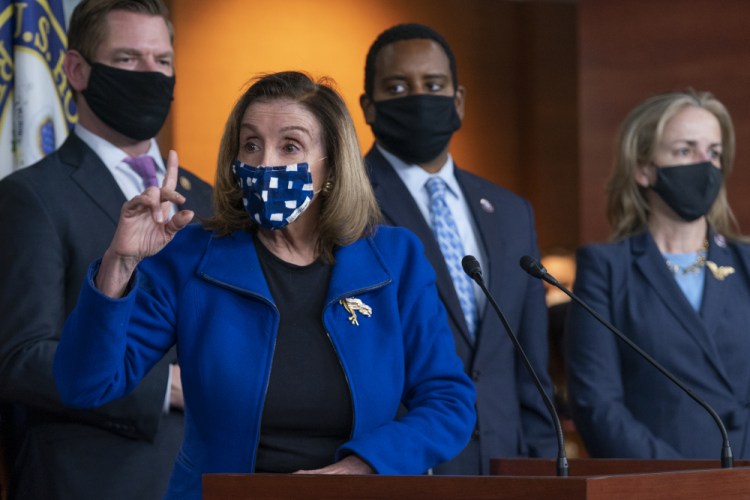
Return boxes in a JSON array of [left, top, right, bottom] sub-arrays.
[[198, 231, 391, 305]]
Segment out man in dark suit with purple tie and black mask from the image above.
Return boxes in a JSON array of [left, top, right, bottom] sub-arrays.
[[0, 0, 211, 500]]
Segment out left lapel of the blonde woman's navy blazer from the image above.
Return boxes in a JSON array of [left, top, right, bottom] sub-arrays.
[[633, 232, 731, 387]]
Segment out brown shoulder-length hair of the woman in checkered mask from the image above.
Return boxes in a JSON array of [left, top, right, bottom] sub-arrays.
[[204, 71, 380, 262]]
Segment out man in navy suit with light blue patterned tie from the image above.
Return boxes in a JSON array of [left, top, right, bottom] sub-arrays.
[[360, 24, 556, 474]]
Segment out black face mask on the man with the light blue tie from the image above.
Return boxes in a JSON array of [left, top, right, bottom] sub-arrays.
[[372, 94, 461, 163]]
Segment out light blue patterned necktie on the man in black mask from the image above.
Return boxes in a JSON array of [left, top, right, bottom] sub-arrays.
[[425, 177, 477, 338]]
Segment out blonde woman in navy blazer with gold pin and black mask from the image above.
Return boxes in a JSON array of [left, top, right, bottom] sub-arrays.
[[566, 91, 750, 459]]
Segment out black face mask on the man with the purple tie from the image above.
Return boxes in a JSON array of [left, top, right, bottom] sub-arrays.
[[82, 63, 175, 141]]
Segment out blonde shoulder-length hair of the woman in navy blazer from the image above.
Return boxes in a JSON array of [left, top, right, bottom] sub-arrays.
[[607, 89, 745, 240]]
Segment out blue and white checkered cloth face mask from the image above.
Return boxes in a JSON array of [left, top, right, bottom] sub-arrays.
[[232, 160, 314, 229]]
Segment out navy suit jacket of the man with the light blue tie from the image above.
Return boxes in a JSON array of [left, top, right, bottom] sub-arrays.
[[365, 147, 557, 474]]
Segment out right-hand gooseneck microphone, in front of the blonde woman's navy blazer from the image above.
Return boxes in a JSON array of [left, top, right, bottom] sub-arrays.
[[520, 255, 734, 469]]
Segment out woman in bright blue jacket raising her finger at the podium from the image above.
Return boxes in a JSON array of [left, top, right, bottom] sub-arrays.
[[55, 72, 475, 499]]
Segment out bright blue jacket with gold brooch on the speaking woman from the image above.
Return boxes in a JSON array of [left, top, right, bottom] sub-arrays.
[[55, 225, 475, 500]]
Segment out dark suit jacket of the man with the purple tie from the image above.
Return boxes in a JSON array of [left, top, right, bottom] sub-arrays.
[[0, 134, 211, 500]]
